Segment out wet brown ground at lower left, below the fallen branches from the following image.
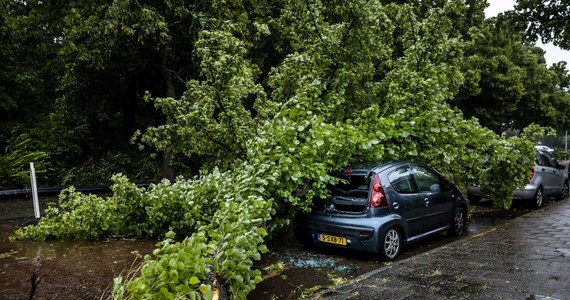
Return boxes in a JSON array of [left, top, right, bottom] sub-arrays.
[[0, 221, 156, 299]]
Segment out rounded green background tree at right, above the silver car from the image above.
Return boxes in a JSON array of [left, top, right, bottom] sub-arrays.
[[451, 16, 570, 134]]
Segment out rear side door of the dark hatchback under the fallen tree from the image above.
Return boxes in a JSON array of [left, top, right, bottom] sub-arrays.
[[388, 165, 425, 237]]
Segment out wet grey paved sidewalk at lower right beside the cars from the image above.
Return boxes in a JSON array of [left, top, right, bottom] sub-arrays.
[[315, 199, 570, 299]]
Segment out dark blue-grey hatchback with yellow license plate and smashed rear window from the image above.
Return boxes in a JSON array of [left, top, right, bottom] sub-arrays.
[[295, 162, 468, 260]]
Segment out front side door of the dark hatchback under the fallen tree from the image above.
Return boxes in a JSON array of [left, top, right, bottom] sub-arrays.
[[412, 165, 454, 232]]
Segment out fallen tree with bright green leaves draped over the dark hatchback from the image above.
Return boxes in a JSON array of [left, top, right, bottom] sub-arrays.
[[16, 0, 541, 299]]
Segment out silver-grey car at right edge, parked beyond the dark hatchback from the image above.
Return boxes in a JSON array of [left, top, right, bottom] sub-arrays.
[[467, 148, 568, 208]]
